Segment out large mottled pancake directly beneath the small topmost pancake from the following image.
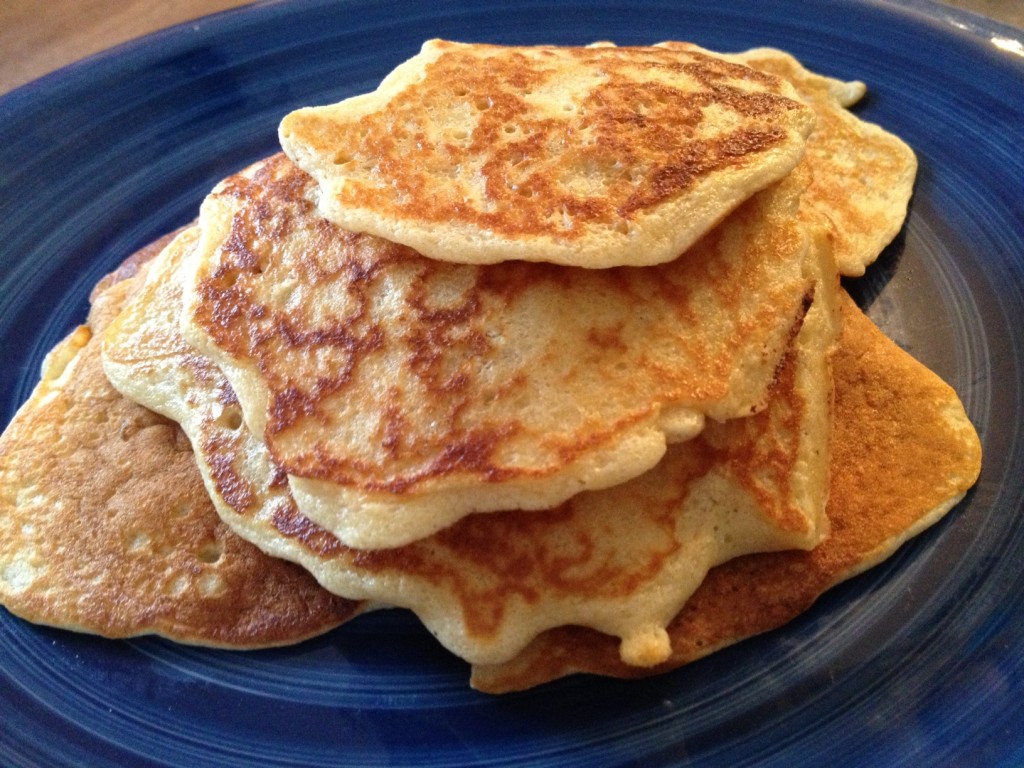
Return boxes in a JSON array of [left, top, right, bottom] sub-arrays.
[[174, 156, 813, 549]]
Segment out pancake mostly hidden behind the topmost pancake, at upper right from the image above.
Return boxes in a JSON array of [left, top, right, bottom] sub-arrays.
[[729, 48, 918, 276]]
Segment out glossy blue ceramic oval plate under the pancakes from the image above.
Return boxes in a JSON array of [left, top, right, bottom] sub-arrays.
[[0, 0, 1024, 768]]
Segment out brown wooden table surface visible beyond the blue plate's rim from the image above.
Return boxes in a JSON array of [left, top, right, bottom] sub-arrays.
[[0, 0, 1024, 93]]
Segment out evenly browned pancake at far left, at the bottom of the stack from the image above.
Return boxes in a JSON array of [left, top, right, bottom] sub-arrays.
[[0, 236, 357, 648]]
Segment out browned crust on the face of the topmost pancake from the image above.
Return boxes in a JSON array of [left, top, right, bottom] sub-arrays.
[[283, 42, 805, 242]]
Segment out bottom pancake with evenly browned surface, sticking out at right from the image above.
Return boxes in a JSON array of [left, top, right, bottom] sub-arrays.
[[471, 296, 981, 693]]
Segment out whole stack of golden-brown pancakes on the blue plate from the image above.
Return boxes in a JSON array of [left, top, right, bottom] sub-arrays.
[[0, 41, 980, 692]]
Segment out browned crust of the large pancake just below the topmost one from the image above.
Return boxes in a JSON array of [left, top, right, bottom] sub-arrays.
[[190, 155, 810, 495]]
